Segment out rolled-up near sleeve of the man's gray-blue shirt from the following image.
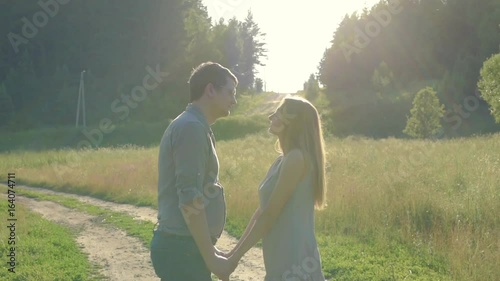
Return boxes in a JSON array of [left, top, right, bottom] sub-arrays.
[[172, 122, 209, 208]]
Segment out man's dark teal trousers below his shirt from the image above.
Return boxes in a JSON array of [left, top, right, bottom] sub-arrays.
[[151, 231, 212, 281]]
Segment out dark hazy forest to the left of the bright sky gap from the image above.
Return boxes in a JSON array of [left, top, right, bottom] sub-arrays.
[[0, 0, 266, 130]]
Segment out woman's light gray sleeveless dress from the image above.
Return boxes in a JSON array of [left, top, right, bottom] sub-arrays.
[[259, 156, 325, 281]]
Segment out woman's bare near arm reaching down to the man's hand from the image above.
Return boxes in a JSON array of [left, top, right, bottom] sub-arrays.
[[230, 150, 305, 262]]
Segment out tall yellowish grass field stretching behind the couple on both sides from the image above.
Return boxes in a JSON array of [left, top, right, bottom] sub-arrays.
[[0, 129, 500, 281]]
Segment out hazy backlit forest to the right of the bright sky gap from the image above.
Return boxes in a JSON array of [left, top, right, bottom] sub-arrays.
[[316, 0, 500, 137]]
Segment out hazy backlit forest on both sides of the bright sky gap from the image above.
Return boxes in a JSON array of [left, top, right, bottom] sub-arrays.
[[0, 0, 500, 137]]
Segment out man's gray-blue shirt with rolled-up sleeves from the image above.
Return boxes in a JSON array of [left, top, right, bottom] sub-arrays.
[[158, 104, 226, 238]]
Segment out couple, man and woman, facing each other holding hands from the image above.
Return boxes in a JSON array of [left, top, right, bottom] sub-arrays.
[[151, 62, 326, 281]]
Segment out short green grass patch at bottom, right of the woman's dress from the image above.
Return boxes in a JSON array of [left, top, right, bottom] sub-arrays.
[[318, 235, 453, 281]]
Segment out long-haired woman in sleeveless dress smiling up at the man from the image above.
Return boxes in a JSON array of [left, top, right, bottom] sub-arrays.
[[227, 97, 326, 281]]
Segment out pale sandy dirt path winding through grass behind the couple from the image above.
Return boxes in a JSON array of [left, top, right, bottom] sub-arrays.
[[18, 186, 265, 281]]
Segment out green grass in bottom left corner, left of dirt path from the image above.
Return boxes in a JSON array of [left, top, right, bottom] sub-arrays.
[[0, 186, 101, 281]]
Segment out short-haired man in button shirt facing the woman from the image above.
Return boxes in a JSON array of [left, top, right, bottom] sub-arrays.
[[151, 62, 238, 281]]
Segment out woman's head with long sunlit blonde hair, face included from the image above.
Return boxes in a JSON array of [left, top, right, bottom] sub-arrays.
[[276, 97, 326, 209]]
